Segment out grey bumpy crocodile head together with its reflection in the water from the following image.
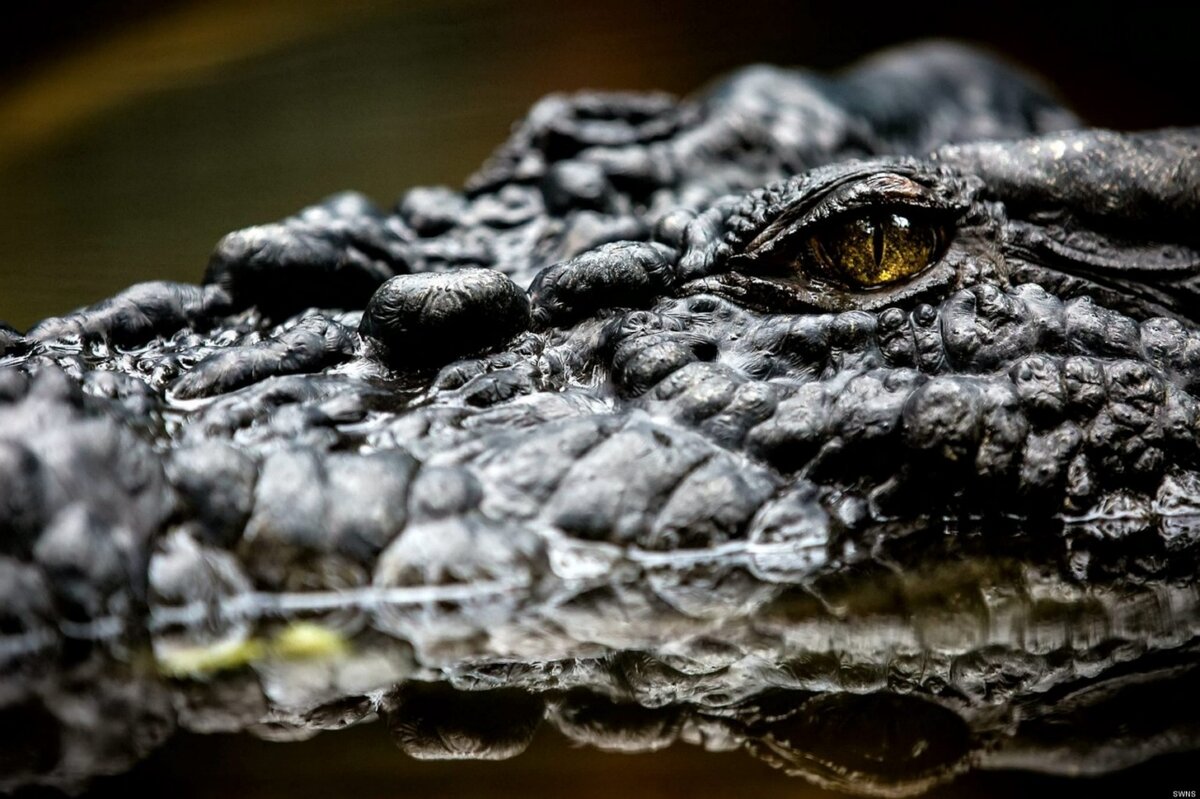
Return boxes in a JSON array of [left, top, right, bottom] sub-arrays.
[[0, 47, 1200, 795]]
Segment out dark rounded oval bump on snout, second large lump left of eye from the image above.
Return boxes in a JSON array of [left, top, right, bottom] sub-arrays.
[[359, 269, 530, 367]]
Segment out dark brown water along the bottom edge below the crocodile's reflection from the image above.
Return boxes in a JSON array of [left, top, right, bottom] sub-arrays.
[[32, 725, 1198, 799]]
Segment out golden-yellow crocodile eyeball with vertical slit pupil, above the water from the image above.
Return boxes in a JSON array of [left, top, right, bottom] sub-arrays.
[[808, 212, 944, 288]]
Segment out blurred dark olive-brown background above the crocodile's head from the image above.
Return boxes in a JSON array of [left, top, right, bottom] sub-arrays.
[[0, 0, 1200, 329]]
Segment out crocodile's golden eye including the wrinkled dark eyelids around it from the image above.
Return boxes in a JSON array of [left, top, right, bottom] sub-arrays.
[[705, 162, 969, 312]]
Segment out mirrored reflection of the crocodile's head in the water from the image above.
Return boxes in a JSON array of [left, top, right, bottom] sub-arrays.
[[7, 523, 1200, 797]]
